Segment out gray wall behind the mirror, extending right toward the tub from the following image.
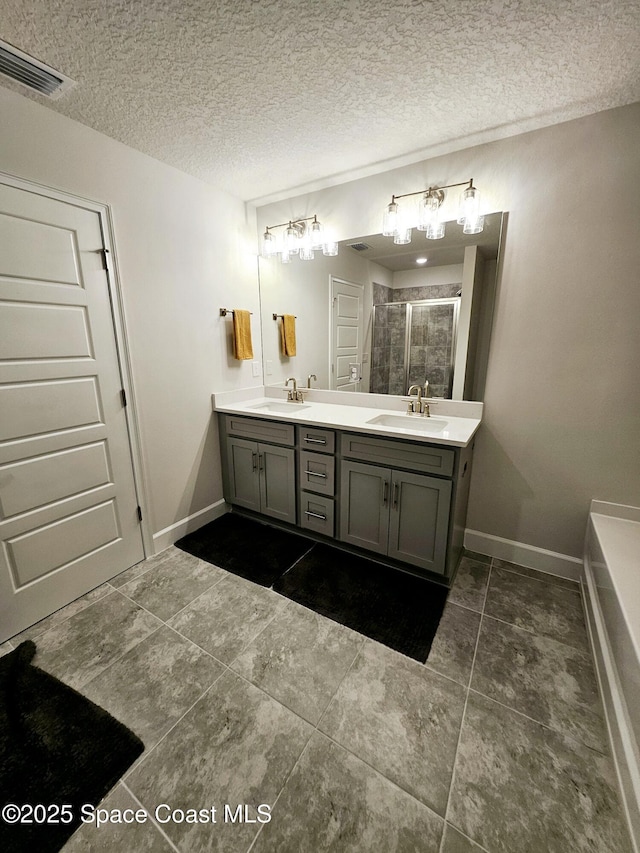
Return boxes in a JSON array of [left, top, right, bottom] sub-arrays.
[[258, 104, 640, 557]]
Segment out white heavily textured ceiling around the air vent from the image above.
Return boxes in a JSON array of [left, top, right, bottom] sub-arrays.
[[0, 0, 640, 200]]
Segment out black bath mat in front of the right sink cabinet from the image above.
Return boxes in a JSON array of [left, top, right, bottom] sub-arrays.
[[273, 545, 447, 663]]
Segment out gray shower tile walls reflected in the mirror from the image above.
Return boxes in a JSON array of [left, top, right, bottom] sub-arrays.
[[369, 284, 460, 397]]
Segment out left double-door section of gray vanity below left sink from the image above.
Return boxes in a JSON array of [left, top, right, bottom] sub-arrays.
[[223, 418, 296, 524]]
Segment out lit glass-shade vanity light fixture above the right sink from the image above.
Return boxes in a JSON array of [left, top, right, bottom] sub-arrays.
[[382, 178, 484, 244]]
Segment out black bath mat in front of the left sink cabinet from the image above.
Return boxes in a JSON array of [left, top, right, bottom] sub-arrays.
[[175, 512, 312, 587]]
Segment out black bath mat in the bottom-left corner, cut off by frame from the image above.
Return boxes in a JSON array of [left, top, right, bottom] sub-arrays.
[[0, 640, 144, 853]]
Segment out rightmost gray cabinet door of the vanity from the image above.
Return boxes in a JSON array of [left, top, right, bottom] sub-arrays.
[[388, 471, 451, 574]]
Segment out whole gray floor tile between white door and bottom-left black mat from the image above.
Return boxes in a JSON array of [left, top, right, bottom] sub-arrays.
[[34, 592, 162, 689]]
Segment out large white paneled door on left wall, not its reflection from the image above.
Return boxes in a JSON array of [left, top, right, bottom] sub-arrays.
[[0, 178, 144, 641]]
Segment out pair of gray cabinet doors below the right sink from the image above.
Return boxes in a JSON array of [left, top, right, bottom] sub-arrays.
[[340, 461, 451, 573]]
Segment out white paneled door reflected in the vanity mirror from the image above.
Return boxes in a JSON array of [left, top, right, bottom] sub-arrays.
[[331, 278, 364, 391]]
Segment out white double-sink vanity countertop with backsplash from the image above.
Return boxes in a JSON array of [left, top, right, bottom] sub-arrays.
[[212, 386, 482, 447]]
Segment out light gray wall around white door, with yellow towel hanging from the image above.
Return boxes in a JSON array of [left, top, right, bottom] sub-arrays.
[[0, 88, 262, 547]]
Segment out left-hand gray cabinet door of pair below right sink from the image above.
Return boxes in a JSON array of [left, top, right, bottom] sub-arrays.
[[340, 462, 391, 554]]
